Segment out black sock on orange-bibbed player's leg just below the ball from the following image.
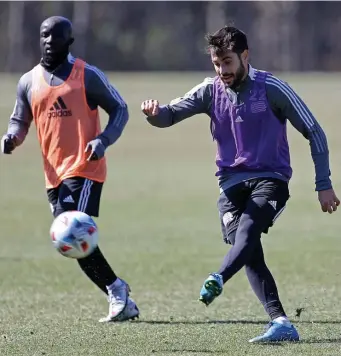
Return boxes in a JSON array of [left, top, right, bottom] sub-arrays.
[[78, 247, 117, 294]]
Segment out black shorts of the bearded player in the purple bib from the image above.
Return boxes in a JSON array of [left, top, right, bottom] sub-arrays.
[[218, 178, 290, 244]]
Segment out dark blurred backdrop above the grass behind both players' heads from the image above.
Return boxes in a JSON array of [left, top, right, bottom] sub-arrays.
[[0, 1, 341, 72]]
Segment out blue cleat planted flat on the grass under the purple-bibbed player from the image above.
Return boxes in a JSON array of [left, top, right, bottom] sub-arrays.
[[249, 321, 300, 343]]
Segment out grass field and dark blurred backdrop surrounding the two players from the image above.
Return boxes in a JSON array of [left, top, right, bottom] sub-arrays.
[[0, 1, 341, 356]]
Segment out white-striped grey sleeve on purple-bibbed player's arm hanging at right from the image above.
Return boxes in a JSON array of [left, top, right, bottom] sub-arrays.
[[266, 76, 332, 191]]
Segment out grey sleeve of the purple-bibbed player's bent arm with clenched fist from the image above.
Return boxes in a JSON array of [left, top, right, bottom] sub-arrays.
[[144, 78, 213, 128]]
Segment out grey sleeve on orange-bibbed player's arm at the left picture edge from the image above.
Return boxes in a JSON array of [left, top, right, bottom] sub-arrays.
[[7, 72, 33, 146]]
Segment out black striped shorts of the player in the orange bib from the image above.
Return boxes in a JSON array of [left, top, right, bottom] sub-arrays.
[[47, 177, 103, 217]]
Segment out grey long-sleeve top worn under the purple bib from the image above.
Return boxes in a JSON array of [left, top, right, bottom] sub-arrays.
[[147, 66, 332, 191]]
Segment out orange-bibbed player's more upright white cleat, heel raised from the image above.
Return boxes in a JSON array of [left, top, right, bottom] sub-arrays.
[[100, 279, 130, 321]]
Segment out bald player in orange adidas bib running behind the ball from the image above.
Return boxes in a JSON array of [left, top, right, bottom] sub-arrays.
[[1, 16, 139, 322]]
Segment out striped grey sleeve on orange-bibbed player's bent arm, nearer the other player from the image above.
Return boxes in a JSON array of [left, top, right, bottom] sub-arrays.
[[85, 66, 129, 147]]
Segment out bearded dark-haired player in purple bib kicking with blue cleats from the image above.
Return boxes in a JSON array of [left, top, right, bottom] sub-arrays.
[[141, 26, 340, 342]]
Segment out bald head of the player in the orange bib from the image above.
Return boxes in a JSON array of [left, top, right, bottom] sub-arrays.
[[40, 16, 74, 69]]
